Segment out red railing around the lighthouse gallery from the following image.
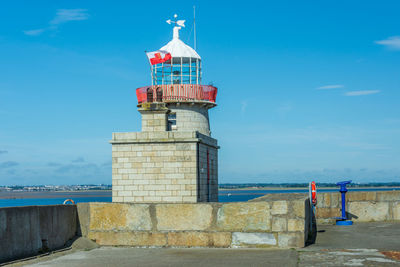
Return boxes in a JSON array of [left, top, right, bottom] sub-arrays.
[[136, 84, 217, 104]]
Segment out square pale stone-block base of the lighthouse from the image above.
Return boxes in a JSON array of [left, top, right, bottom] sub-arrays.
[[111, 132, 218, 203]]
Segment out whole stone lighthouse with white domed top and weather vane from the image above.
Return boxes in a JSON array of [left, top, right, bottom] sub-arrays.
[[110, 15, 219, 203]]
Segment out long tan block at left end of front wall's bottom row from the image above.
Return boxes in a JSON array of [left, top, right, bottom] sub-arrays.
[[88, 231, 167, 247]]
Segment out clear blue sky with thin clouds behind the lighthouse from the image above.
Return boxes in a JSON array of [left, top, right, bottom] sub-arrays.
[[0, 0, 400, 185]]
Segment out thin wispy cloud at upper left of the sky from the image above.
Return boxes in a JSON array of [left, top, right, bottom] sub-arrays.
[[23, 8, 89, 36]]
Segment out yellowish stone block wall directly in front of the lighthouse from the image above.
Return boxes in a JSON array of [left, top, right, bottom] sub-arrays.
[[78, 198, 309, 248]]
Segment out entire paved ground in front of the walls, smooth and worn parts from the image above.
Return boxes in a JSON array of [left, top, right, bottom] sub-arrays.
[[8, 223, 400, 267]]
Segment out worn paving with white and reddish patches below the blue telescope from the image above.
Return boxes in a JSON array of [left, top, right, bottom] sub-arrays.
[[297, 222, 400, 267]]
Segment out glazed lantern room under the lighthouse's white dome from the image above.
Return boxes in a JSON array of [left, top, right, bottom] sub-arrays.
[[151, 57, 201, 85]]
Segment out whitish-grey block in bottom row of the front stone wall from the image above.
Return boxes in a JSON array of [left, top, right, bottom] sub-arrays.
[[232, 232, 276, 247]]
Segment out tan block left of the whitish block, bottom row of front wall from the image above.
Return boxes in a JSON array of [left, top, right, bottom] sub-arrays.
[[168, 232, 231, 247]]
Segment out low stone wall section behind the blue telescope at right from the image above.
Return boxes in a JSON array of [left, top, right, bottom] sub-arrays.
[[317, 191, 400, 224]]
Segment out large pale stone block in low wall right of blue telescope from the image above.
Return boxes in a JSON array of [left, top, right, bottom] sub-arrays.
[[348, 201, 389, 222]]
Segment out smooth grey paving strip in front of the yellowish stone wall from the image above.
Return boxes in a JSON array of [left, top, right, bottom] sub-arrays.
[[21, 247, 297, 267]]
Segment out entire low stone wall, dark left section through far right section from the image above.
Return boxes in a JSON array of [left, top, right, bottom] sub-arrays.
[[0, 191, 400, 262]]
